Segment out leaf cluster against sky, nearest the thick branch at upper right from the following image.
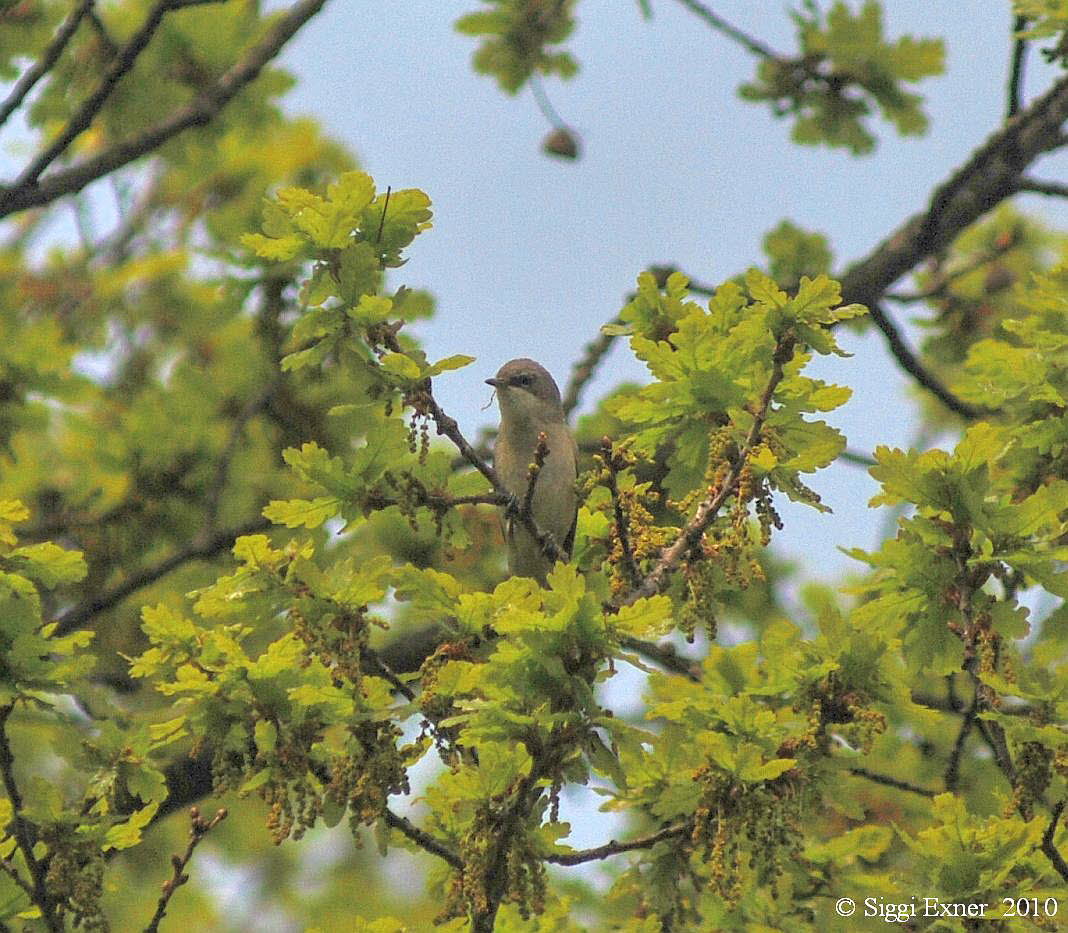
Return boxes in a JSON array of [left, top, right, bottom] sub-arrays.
[[741, 0, 944, 154]]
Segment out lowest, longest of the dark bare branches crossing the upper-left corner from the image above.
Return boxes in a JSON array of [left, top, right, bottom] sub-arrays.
[[0, 0, 326, 217]]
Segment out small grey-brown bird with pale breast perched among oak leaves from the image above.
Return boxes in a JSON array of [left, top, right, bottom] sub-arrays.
[[486, 359, 578, 585]]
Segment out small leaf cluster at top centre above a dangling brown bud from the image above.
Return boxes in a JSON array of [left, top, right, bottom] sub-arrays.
[[456, 0, 579, 94]]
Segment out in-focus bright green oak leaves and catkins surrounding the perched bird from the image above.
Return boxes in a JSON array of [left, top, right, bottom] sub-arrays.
[[135, 165, 969, 929]]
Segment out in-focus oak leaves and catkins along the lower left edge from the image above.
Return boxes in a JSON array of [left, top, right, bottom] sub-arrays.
[[0, 500, 175, 929]]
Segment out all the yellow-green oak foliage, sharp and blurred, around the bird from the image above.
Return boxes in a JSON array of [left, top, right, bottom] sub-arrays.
[[0, 0, 1068, 933]]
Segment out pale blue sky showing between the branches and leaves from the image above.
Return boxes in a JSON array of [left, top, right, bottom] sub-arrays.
[[283, 0, 1068, 579]]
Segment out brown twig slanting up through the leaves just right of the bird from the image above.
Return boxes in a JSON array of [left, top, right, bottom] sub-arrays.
[[613, 337, 794, 607]]
